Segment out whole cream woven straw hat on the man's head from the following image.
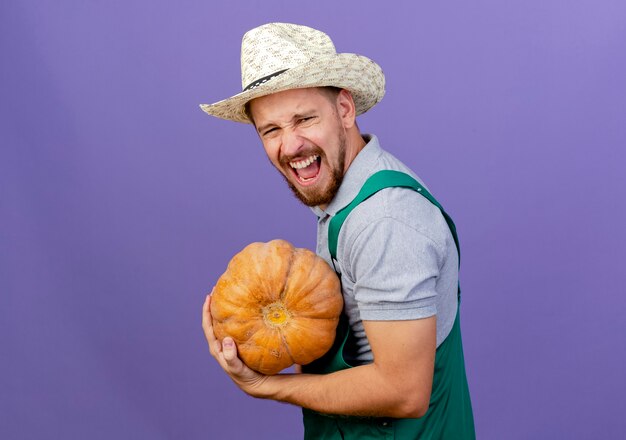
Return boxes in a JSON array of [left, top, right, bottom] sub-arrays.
[[200, 23, 385, 123]]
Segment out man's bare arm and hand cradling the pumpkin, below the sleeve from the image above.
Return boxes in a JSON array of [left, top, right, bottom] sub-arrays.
[[203, 297, 436, 417]]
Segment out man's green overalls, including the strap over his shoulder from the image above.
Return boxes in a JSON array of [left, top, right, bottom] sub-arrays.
[[302, 170, 476, 440]]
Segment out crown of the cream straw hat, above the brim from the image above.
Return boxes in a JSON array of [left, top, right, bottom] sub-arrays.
[[241, 23, 337, 89]]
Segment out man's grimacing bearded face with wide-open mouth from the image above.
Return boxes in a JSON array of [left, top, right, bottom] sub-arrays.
[[250, 88, 346, 206]]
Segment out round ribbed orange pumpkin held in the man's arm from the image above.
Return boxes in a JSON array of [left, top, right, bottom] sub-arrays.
[[211, 240, 343, 374]]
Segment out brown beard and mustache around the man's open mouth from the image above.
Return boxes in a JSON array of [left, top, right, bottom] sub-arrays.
[[279, 132, 346, 206]]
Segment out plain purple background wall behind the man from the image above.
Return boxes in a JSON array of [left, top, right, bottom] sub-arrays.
[[0, 0, 626, 440]]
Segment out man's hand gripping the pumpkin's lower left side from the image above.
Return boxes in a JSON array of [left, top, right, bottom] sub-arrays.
[[202, 292, 267, 397]]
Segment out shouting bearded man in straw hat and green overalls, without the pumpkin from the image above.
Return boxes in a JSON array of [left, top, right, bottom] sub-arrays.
[[201, 23, 475, 440]]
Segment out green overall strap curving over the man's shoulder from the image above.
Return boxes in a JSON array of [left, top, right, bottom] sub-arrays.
[[328, 170, 461, 265]]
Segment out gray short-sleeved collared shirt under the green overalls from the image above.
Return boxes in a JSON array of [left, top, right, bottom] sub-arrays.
[[312, 135, 459, 364]]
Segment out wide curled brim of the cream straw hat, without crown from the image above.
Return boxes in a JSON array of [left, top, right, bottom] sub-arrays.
[[200, 53, 385, 123]]
